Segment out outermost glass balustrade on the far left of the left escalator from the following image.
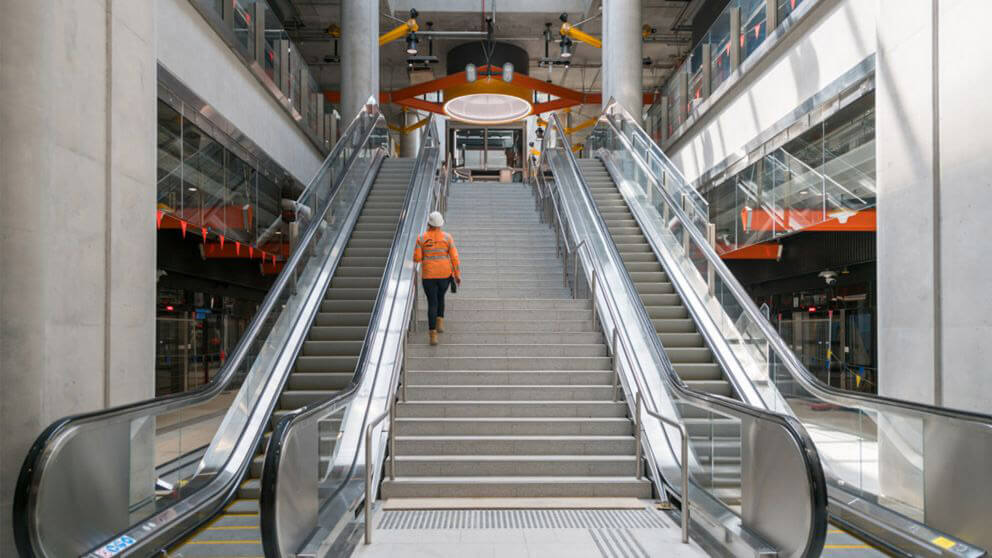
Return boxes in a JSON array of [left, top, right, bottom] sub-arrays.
[[13, 99, 387, 557]]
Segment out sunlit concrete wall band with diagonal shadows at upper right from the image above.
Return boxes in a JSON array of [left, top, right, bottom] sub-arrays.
[[668, 0, 878, 181]]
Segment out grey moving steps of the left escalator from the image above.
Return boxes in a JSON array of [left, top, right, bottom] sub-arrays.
[[173, 159, 414, 557]]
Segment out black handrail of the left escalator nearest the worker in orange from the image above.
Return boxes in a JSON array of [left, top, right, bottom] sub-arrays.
[[259, 114, 439, 557]]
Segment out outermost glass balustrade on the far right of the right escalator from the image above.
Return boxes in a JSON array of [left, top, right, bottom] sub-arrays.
[[591, 100, 992, 556]]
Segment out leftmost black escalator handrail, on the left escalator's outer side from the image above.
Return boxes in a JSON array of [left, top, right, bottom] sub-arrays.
[[12, 98, 385, 556]]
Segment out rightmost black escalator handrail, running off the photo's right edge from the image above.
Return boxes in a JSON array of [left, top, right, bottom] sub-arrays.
[[600, 100, 992, 428]]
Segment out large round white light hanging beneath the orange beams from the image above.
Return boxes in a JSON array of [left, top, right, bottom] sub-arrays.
[[444, 77, 533, 126]]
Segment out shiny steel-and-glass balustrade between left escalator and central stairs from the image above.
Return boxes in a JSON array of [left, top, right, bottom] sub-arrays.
[[260, 117, 447, 558]]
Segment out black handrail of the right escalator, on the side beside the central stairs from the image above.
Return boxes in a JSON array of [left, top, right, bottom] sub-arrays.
[[542, 114, 827, 556]]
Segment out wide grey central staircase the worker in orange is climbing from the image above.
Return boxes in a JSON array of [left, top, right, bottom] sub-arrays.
[[382, 183, 651, 498]]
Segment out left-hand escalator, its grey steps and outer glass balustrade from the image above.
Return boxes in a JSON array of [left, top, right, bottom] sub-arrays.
[[13, 99, 433, 558]]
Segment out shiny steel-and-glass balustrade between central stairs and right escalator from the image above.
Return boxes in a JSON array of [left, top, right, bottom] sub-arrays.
[[535, 112, 826, 556]]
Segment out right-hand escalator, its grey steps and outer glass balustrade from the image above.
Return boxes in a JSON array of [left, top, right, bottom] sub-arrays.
[[576, 100, 992, 556]]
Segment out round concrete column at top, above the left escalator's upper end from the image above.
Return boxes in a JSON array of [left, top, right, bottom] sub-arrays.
[[341, 0, 379, 123]]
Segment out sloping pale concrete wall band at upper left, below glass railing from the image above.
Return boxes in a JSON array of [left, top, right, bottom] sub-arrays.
[[155, 0, 322, 184]]
